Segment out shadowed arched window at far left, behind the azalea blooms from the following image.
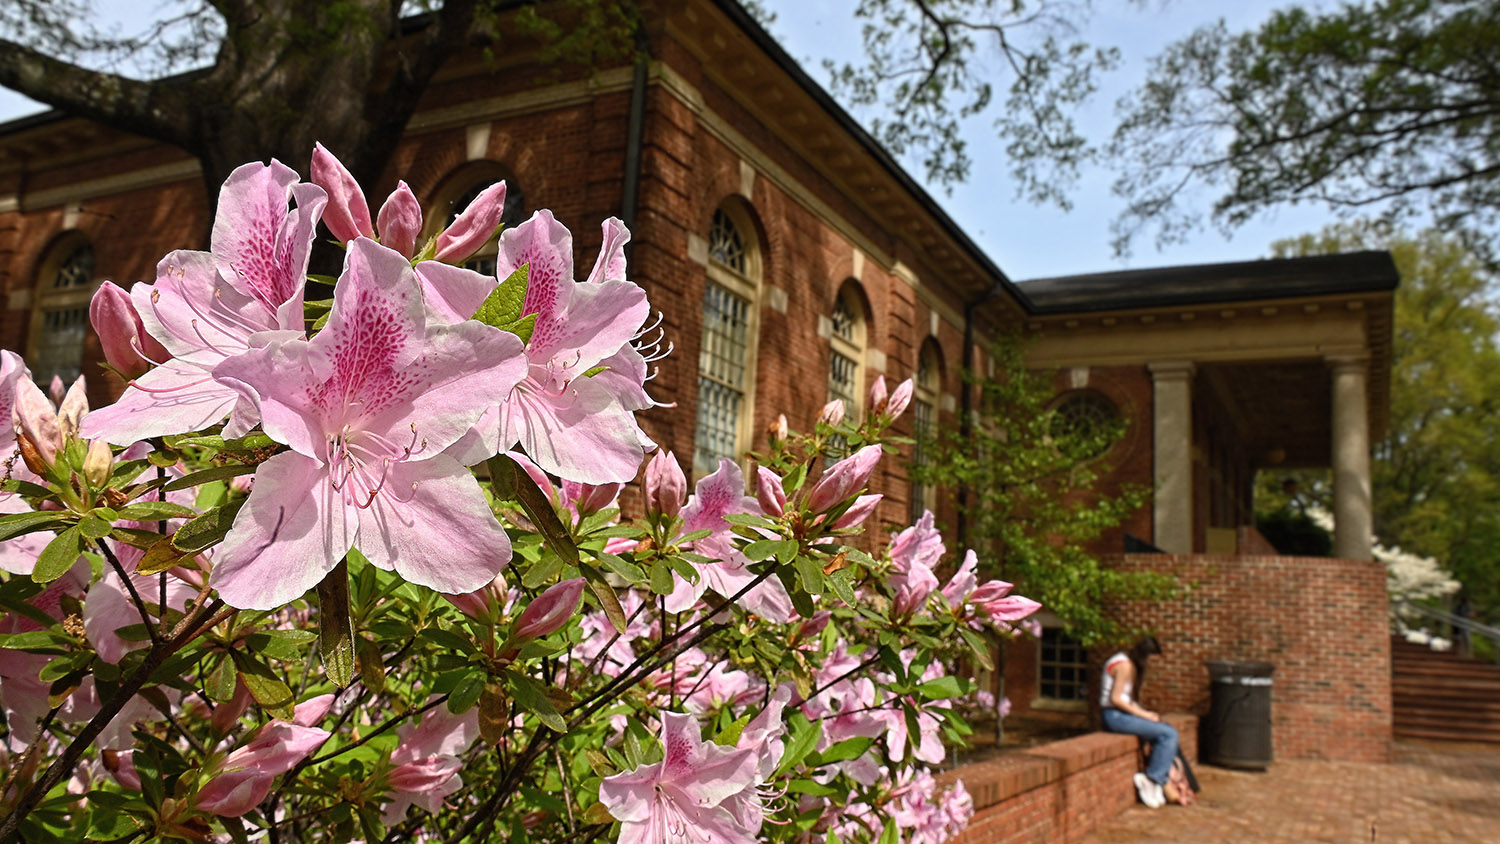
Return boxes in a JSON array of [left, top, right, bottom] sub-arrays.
[[27, 231, 95, 388]]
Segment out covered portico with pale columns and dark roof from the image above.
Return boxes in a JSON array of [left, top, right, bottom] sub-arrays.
[[1019, 252, 1398, 559]]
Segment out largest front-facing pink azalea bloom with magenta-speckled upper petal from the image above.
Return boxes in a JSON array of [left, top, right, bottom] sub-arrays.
[[210, 238, 525, 609]]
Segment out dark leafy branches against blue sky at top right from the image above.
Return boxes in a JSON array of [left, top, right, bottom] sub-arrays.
[[1110, 0, 1500, 258]]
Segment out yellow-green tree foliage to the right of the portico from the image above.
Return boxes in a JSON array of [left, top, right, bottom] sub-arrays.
[[1275, 222, 1500, 621]]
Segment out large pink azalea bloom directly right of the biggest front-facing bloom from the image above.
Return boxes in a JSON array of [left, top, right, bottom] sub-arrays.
[[419, 211, 654, 484]]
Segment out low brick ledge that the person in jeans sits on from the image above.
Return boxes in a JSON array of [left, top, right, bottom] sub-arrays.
[[938, 714, 1199, 844]]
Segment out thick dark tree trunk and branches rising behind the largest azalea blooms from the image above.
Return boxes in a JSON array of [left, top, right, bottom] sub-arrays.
[[0, 0, 636, 196]]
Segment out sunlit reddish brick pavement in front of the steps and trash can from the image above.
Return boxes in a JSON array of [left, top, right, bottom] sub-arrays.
[[1080, 742, 1500, 844]]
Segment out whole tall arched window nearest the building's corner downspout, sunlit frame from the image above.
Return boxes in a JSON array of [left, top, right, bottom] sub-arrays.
[[693, 204, 761, 477]]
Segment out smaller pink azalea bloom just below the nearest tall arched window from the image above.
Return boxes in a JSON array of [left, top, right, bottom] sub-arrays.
[[666, 459, 797, 624]]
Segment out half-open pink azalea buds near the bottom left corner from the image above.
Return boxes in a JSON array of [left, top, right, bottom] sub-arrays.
[[195, 696, 333, 817]]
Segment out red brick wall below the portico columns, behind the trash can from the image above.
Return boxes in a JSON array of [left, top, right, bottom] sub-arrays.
[[1113, 555, 1391, 762]]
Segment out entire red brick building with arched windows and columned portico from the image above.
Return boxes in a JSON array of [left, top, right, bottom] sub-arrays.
[[0, 0, 1395, 759]]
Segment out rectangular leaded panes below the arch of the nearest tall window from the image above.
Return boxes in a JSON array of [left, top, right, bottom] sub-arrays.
[[693, 282, 750, 477]]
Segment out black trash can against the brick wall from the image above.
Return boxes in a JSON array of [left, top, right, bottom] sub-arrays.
[[1200, 660, 1277, 771]]
